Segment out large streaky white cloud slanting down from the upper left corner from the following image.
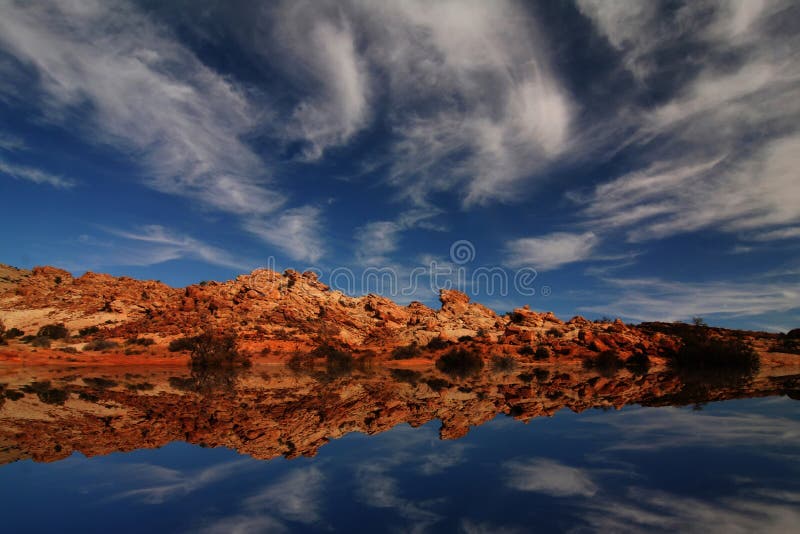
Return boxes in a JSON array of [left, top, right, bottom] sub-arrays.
[[0, 1, 282, 214]]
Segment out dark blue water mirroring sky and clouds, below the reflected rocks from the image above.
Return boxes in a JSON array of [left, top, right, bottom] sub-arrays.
[[0, 368, 800, 533]]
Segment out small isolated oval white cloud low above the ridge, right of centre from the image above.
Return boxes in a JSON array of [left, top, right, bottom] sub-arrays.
[[506, 232, 599, 271]]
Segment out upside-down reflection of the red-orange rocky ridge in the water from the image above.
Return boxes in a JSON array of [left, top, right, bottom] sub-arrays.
[[0, 365, 800, 464]]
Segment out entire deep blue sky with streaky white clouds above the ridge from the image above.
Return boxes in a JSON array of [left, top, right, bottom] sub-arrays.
[[0, 0, 800, 330]]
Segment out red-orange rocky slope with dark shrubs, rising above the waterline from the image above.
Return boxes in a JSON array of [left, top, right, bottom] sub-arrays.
[[0, 266, 792, 363]]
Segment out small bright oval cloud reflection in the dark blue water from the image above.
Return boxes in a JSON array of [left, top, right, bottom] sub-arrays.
[[503, 458, 597, 497]]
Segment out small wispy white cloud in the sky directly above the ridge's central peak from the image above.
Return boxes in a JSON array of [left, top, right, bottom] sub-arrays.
[[245, 206, 325, 262]]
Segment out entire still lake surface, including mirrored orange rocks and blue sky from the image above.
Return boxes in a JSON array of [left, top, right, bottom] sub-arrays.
[[0, 367, 800, 533]]
